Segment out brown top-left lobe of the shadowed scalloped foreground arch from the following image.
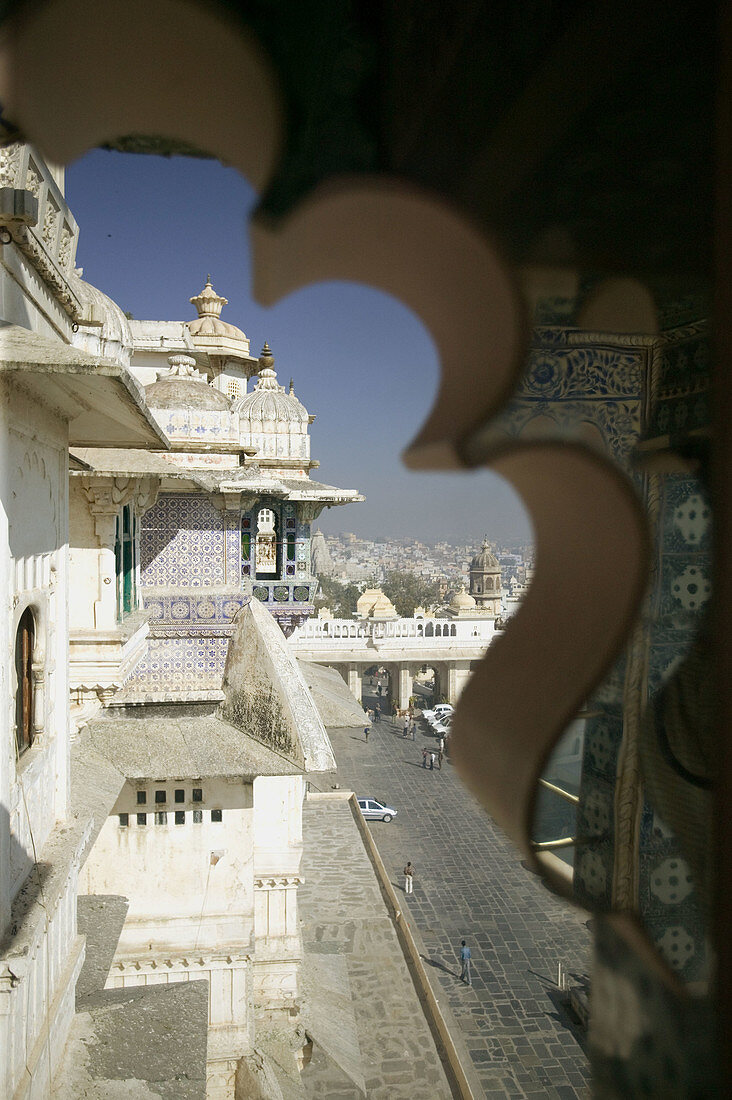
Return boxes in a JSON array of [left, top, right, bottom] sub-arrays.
[[0, 0, 282, 190]]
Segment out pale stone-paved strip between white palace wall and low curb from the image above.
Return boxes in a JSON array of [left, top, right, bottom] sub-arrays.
[[298, 800, 452, 1100]]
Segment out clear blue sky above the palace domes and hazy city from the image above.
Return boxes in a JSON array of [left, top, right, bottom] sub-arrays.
[[66, 150, 531, 542]]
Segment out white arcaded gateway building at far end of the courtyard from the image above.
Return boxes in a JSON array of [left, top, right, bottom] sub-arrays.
[[288, 614, 496, 710]]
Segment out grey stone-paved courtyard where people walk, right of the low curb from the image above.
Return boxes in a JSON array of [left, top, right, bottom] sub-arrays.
[[324, 700, 590, 1098]]
